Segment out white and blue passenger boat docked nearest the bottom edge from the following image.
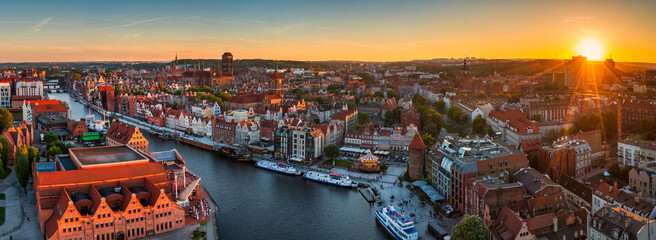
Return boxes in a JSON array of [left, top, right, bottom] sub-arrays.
[[376, 205, 419, 240]]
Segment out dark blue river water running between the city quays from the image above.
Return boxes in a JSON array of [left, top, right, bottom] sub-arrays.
[[50, 93, 386, 239]]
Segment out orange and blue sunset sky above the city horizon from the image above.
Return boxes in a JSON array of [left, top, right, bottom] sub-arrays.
[[0, 0, 656, 62]]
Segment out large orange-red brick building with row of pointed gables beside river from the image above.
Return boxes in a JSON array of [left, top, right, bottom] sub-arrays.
[[32, 146, 208, 240]]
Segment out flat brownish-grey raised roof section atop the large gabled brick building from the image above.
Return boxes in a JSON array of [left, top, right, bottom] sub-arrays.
[[69, 145, 148, 168]]
